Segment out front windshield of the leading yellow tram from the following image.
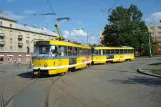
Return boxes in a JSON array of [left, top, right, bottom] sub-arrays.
[[34, 45, 57, 56]]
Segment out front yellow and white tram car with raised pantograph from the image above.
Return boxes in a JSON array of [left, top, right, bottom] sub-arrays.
[[32, 40, 91, 75]]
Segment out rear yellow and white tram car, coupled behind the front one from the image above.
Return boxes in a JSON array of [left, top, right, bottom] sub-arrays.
[[92, 47, 134, 64]]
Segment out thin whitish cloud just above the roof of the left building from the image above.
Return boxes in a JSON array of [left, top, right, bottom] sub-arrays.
[[3, 10, 25, 20]]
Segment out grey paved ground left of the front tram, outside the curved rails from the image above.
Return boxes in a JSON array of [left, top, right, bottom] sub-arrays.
[[0, 64, 34, 103]]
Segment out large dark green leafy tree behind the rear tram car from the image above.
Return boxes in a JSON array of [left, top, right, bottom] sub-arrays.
[[103, 4, 152, 54]]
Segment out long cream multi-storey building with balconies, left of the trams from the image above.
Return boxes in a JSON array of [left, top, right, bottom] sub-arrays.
[[0, 11, 57, 63]]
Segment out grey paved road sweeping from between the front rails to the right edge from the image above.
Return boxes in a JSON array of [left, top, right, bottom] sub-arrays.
[[6, 58, 161, 107]]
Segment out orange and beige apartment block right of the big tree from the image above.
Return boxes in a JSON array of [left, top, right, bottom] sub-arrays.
[[148, 25, 161, 54]]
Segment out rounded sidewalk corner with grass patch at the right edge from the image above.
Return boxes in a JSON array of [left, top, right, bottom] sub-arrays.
[[137, 63, 161, 78]]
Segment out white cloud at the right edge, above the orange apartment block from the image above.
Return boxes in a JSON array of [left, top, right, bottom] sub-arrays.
[[145, 12, 161, 24]]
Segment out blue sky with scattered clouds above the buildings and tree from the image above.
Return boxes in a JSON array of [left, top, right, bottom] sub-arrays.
[[0, 0, 161, 44]]
